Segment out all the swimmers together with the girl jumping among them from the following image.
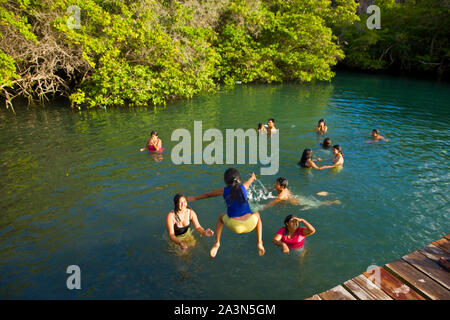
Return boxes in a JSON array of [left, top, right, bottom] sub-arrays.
[[140, 118, 388, 258]]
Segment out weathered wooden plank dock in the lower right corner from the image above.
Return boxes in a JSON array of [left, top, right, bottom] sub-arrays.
[[306, 234, 450, 300]]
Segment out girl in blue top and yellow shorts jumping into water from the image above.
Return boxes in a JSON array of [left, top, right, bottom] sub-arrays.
[[188, 168, 265, 258]]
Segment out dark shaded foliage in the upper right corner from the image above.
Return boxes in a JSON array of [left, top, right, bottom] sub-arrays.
[[341, 0, 450, 79]]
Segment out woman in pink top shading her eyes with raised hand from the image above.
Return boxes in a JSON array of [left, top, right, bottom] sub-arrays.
[[272, 214, 316, 253]]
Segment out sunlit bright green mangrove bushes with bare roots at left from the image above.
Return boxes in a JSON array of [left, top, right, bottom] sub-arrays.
[[0, 0, 357, 107]]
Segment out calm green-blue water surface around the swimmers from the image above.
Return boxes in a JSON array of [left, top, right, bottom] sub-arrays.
[[0, 73, 450, 299]]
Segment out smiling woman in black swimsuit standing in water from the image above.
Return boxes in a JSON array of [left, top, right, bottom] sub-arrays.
[[166, 193, 214, 250]]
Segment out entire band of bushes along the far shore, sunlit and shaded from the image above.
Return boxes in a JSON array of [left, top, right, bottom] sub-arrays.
[[0, 0, 450, 112]]
